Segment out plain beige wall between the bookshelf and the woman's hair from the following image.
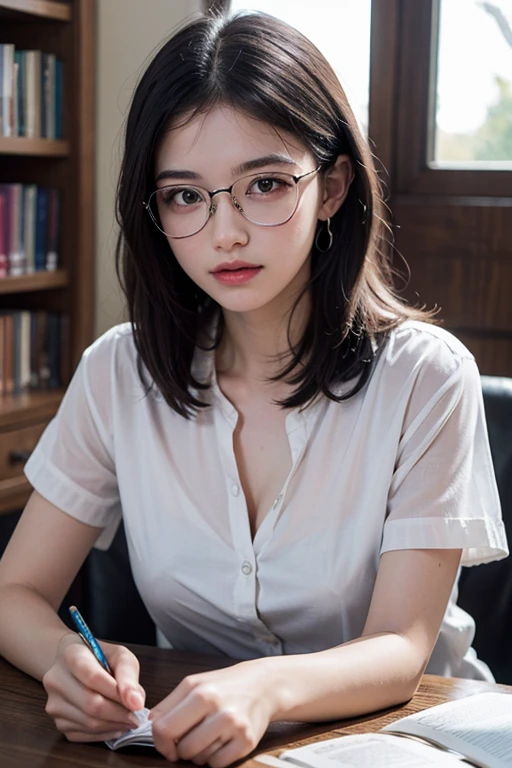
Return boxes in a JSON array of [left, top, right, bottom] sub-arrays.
[[94, 0, 201, 336]]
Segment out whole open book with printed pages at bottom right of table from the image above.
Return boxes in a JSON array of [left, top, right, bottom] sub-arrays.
[[254, 693, 512, 768]]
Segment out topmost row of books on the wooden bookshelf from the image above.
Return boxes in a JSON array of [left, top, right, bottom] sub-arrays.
[[0, 43, 63, 139]]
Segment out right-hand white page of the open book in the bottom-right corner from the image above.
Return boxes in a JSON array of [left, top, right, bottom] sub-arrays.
[[382, 693, 512, 768]]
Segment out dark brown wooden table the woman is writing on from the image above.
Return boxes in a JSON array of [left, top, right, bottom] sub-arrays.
[[0, 646, 511, 768]]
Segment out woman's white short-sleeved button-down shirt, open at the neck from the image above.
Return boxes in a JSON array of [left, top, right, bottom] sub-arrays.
[[25, 322, 507, 677]]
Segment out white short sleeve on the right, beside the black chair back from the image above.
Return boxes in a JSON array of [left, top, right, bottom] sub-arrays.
[[381, 342, 508, 565]]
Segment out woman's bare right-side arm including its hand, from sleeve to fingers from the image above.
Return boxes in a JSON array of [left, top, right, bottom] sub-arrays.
[[151, 550, 461, 768]]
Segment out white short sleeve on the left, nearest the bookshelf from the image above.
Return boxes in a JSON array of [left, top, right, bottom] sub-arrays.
[[25, 336, 121, 549]]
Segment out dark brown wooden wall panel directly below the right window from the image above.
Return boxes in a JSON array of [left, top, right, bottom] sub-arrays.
[[392, 201, 512, 331]]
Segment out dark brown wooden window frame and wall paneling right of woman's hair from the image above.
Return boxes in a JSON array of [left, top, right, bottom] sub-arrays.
[[369, 0, 512, 377]]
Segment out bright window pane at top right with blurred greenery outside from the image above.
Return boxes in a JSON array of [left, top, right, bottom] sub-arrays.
[[431, 0, 512, 170]]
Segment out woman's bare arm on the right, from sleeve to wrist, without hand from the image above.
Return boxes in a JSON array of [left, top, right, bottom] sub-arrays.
[[262, 550, 461, 720]]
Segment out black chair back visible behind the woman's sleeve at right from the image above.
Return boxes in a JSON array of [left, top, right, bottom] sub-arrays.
[[458, 376, 512, 685]]
